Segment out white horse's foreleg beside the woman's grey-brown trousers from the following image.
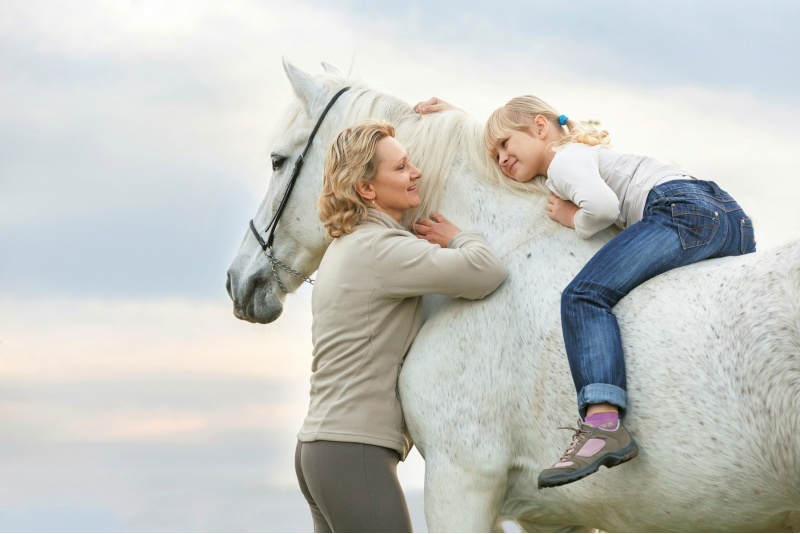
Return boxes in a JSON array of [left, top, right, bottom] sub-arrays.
[[425, 457, 508, 532]]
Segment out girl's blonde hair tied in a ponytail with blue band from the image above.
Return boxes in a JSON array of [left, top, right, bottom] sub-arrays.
[[483, 95, 611, 161]]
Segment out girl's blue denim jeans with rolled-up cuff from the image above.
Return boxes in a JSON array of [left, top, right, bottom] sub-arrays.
[[561, 180, 755, 417]]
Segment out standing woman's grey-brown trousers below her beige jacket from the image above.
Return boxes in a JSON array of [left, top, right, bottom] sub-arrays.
[[294, 441, 412, 532]]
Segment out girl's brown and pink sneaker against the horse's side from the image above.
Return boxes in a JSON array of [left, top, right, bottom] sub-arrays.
[[539, 419, 639, 489]]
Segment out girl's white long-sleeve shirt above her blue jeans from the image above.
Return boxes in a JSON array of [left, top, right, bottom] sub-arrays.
[[546, 143, 693, 239]]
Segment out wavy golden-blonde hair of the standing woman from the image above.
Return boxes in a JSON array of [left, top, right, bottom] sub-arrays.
[[317, 120, 394, 239]]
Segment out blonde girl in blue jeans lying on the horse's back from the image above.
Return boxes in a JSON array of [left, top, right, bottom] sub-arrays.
[[415, 96, 755, 488]]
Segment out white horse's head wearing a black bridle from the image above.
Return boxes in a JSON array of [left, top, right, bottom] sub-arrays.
[[226, 60, 346, 323]]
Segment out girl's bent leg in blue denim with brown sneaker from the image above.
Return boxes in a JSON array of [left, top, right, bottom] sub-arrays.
[[538, 217, 680, 488]]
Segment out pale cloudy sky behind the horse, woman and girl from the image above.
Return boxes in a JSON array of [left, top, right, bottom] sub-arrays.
[[0, 0, 800, 531]]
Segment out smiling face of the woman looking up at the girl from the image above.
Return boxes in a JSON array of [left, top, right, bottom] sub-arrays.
[[361, 137, 422, 222]]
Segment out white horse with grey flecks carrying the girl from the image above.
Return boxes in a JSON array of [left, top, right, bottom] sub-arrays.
[[228, 63, 800, 531]]
